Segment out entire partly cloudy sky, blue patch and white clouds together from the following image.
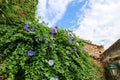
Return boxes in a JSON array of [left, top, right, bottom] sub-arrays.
[[36, 0, 120, 49]]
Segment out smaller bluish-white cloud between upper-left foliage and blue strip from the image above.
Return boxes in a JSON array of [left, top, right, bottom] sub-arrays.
[[37, 0, 72, 25]]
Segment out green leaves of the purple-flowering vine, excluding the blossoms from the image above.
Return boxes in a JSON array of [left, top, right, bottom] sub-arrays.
[[0, 22, 100, 80]]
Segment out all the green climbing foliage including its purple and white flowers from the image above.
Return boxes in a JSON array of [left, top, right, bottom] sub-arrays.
[[0, 0, 101, 80]]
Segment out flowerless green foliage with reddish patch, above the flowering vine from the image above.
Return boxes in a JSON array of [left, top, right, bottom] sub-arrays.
[[0, 0, 38, 24]]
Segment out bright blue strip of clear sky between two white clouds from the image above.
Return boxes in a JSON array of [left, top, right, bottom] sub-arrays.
[[56, 0, 87, 30]]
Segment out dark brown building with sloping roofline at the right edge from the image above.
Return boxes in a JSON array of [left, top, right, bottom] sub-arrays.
[[102, 39, 120, 80]]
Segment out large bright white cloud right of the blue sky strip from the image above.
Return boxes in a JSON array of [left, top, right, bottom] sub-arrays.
[[75, 0, 120, 48]]
